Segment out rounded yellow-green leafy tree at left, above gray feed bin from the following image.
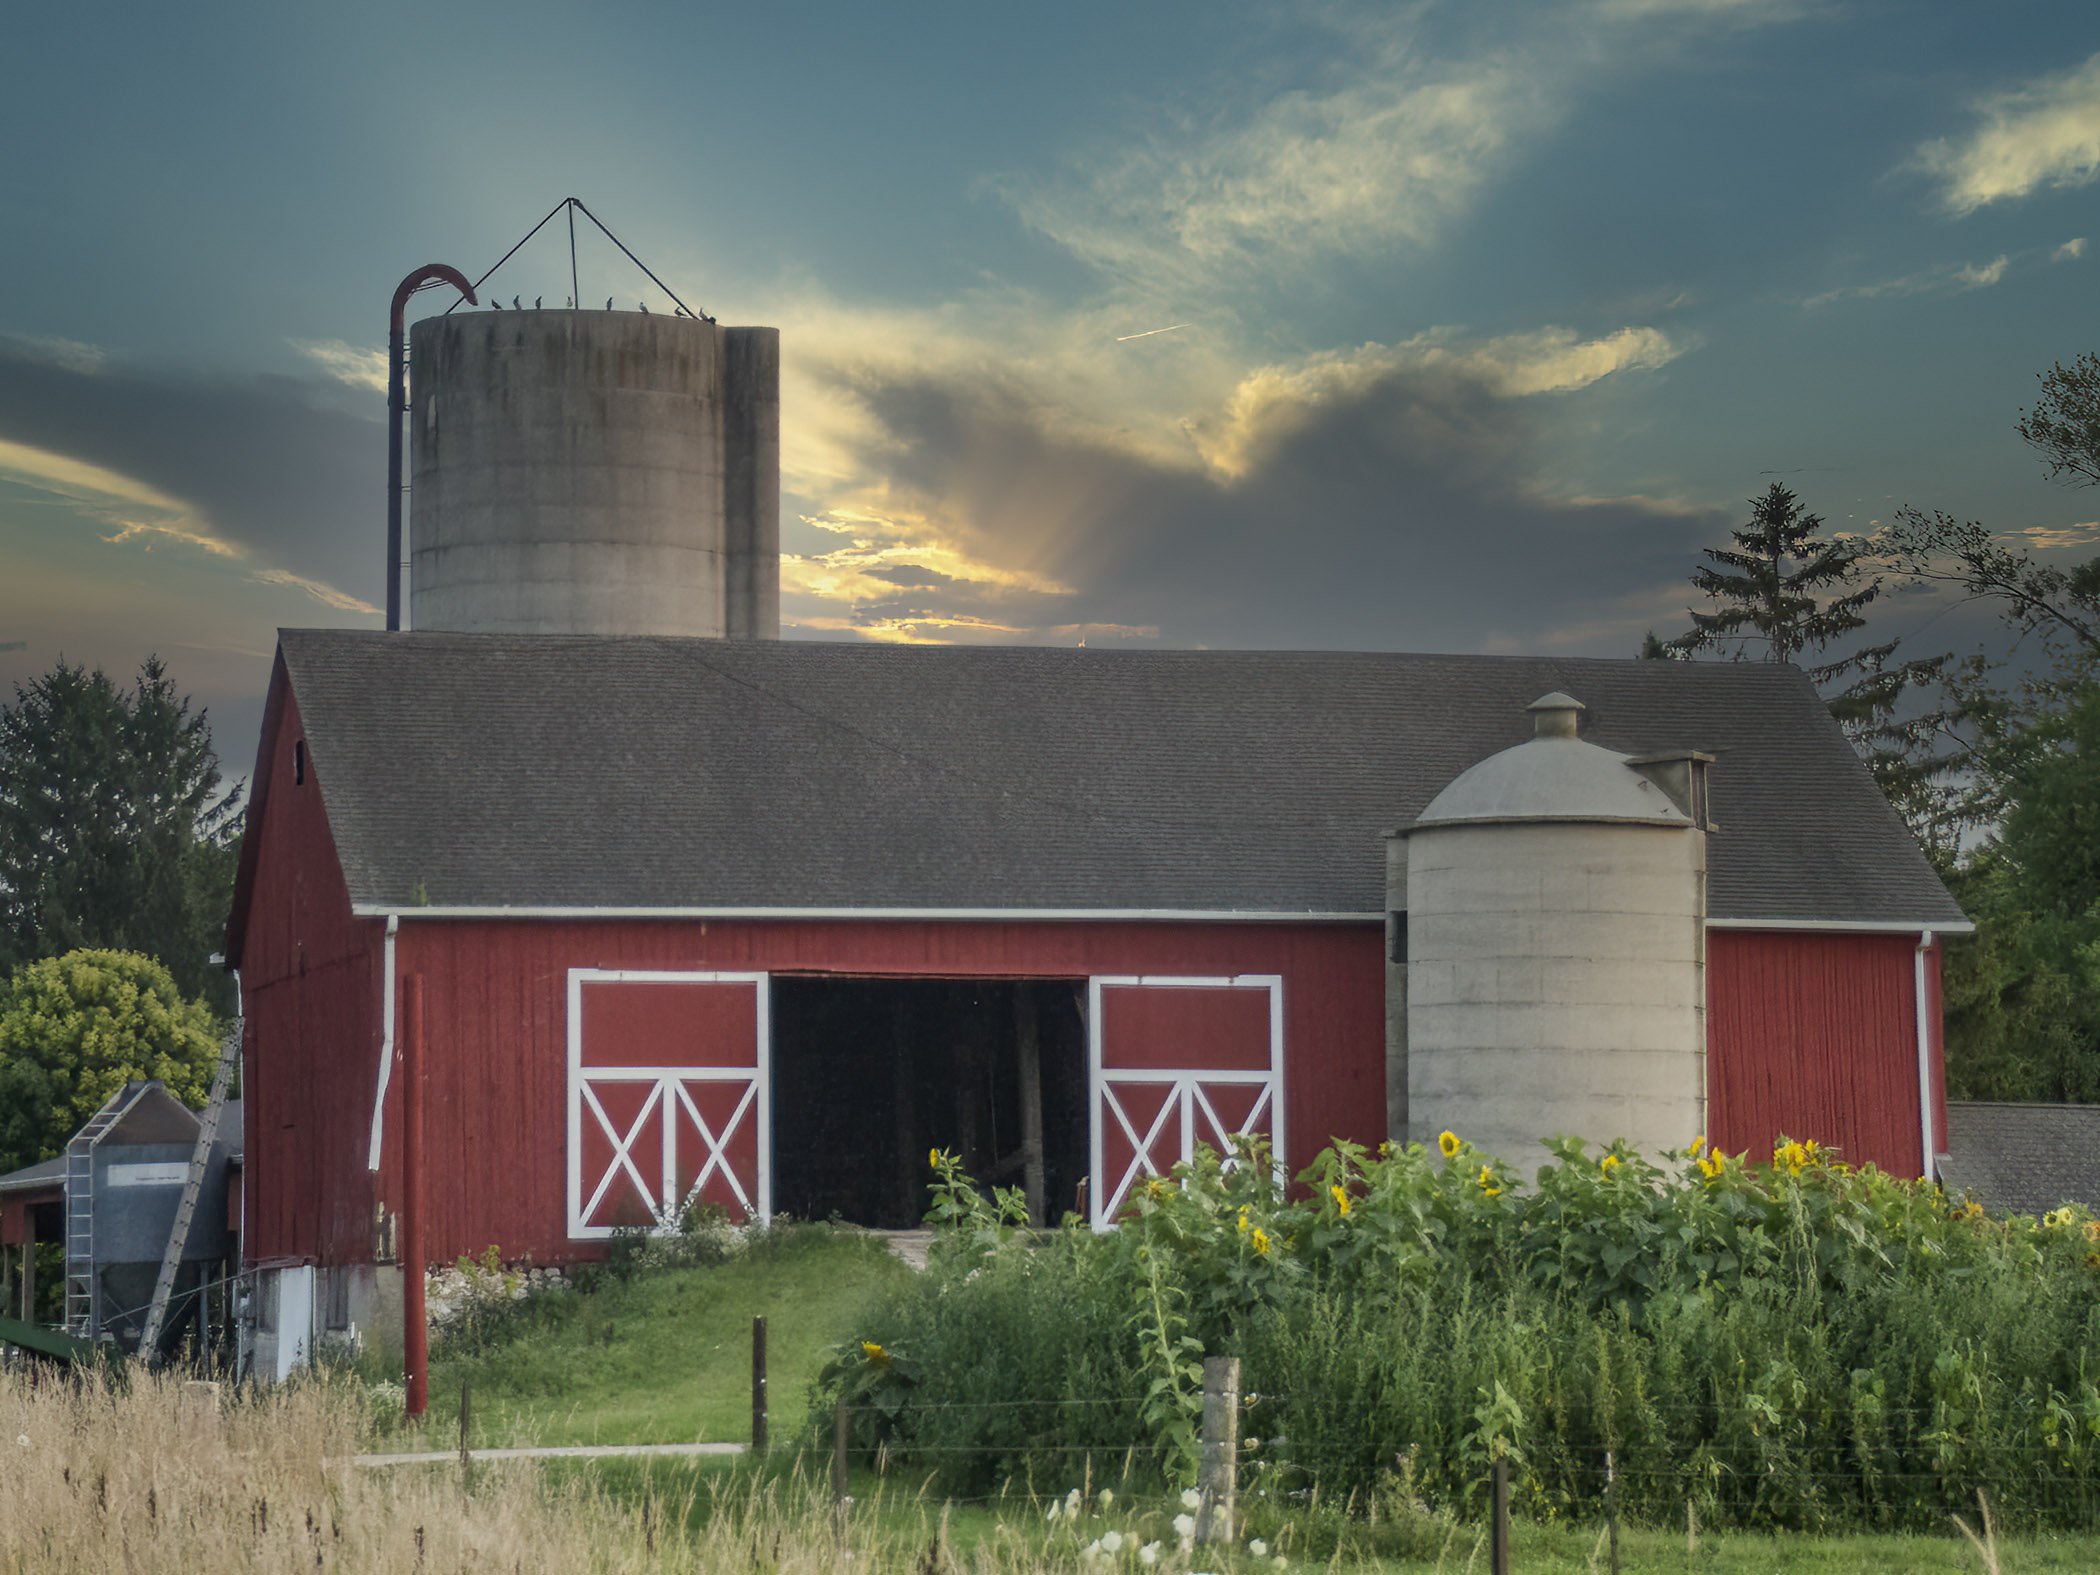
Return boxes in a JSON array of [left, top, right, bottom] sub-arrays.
[[0, 951, 218, 1172]]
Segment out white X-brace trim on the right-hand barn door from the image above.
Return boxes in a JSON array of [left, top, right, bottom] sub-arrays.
[[1086, 974, 1285, 1231]]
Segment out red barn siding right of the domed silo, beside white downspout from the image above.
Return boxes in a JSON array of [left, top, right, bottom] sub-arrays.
[[1707, 930, 1947, 1176]]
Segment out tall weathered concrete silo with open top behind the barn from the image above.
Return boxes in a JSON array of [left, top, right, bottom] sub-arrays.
[[410, 311, 779, 638]]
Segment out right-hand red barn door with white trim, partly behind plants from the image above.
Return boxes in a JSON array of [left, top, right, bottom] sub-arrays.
[[1086, 974, 1283, 1229]]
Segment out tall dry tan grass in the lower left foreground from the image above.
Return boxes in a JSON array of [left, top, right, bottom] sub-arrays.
[[0, 1373, 1077, 1575]]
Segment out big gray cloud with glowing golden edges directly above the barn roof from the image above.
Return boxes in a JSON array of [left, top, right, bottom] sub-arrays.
[[783, 315, 1726, 653]]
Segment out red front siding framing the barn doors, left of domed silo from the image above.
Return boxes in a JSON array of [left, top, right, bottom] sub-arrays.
[[369, 916, 1386, 1262]]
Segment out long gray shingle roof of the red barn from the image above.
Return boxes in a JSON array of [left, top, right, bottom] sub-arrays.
[[279, 630, 1959, 924]]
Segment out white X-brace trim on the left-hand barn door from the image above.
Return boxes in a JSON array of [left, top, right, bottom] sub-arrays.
[[567, 968, 773, 1241]]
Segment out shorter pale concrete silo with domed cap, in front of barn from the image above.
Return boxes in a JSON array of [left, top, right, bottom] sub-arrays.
[[1399, 693, 1705, 1176]]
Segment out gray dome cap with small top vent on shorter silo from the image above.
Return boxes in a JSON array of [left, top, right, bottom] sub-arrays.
[[1409, 691, 1693, 832]]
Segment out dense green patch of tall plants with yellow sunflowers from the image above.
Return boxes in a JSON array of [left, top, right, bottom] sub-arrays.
[[819, 1134, 2100, 1529]]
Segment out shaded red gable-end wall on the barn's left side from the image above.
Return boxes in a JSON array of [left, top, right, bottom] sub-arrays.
[[233, 664, 384, 1262]]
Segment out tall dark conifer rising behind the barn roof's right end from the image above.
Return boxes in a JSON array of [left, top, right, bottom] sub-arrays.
[[1640, 481, 1949, 840]]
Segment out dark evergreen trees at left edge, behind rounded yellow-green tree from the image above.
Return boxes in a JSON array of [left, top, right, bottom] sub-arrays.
[[0, 657, 239, 1010]]
